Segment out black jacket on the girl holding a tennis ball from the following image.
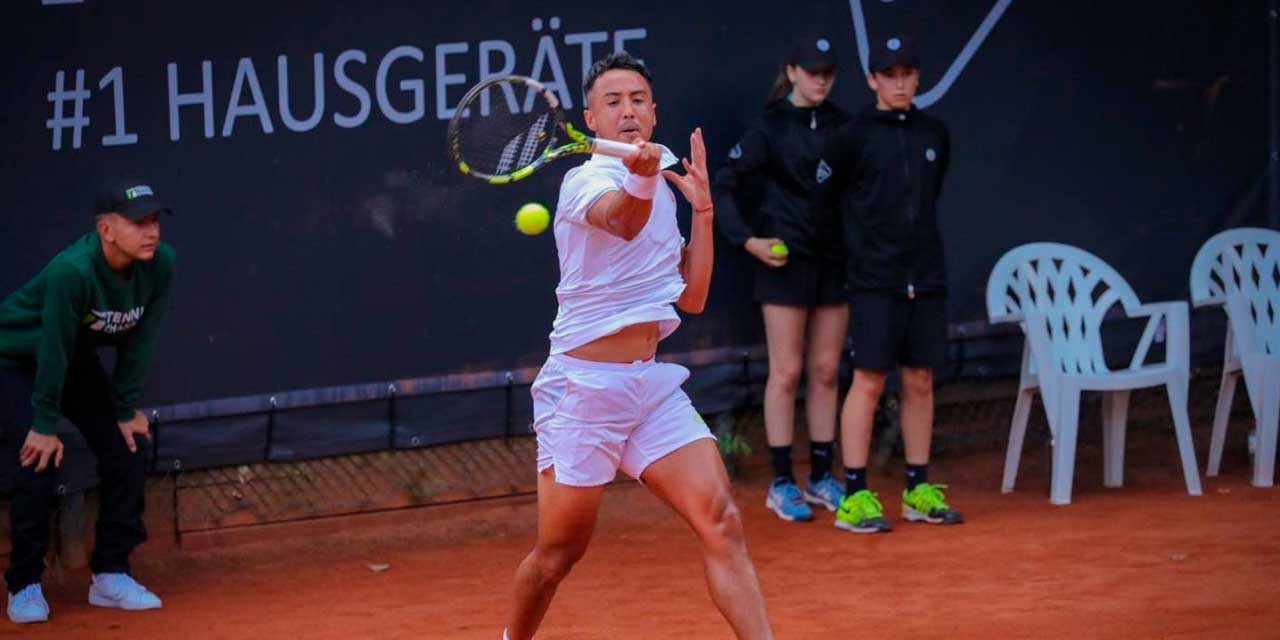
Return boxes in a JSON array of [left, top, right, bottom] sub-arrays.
[[712, 99, 849, 260]]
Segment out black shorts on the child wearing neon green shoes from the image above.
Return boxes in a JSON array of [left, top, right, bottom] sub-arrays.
[[849, 292, 947, 371]]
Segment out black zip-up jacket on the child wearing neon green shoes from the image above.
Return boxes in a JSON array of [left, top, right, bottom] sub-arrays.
[[815, 105, 951, 296]]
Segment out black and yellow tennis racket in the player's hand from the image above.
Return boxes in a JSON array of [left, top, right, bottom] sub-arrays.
[[448, 76, 636, 184]]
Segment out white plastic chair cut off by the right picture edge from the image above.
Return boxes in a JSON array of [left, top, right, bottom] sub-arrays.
[[1192, 228, 1280, 486]]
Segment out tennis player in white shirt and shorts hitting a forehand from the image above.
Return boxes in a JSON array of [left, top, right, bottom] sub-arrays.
[[504, 52, 773, 640]]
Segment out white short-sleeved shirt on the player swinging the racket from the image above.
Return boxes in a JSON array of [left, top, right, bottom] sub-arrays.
[[550, 147, 685, 355]]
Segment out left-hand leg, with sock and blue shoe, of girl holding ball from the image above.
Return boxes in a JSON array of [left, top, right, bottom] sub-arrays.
[[760, 303, 813, 521]]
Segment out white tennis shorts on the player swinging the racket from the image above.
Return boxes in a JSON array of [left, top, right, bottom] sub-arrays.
[[532, 355, 716, 486]]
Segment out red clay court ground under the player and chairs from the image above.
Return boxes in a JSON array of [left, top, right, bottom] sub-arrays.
[[0, 433, 1280, 640]]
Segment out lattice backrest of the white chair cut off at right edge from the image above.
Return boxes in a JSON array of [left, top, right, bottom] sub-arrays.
[[1190, 227, 1280, 355]]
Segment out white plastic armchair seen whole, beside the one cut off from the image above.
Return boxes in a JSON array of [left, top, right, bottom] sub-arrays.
[[987, 242, 1201, 504]]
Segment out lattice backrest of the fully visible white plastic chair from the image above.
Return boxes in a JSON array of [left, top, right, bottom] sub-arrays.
[[987, 242, 1140, 374]]
